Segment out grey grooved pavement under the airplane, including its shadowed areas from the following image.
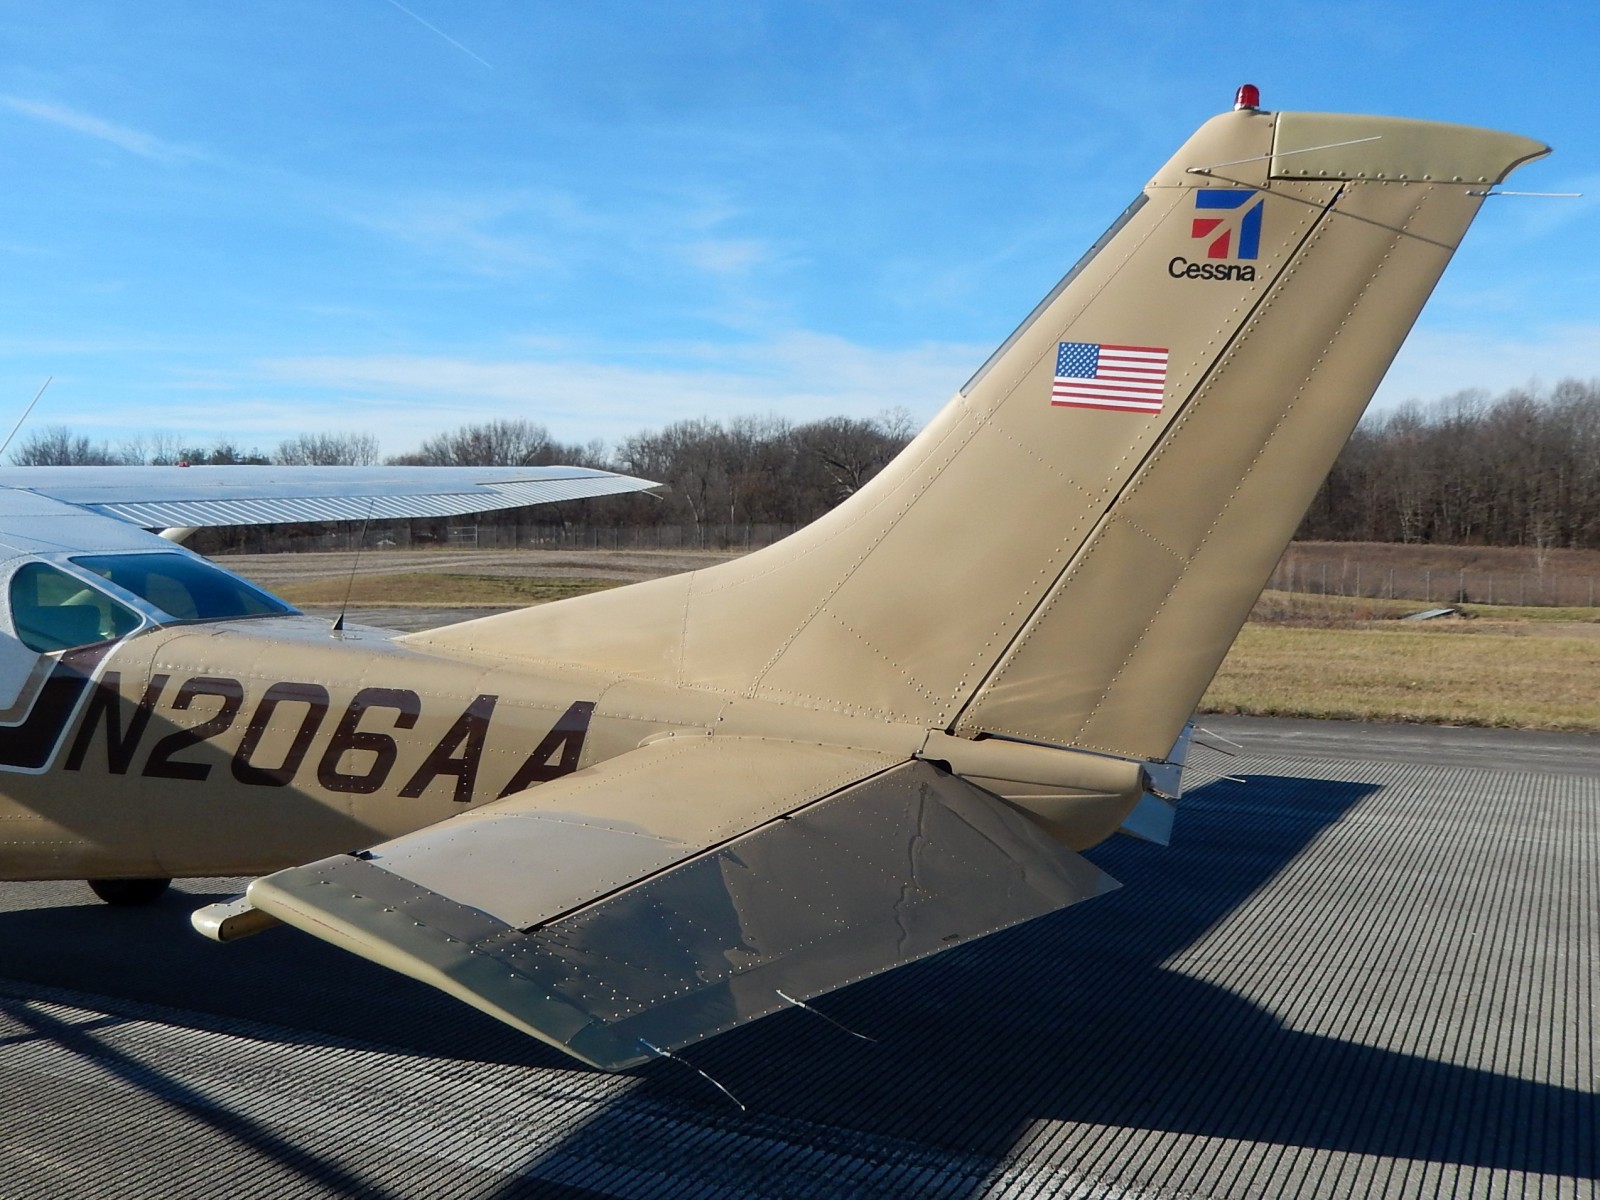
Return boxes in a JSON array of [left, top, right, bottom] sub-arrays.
[[0, 722, 1600, 1200]]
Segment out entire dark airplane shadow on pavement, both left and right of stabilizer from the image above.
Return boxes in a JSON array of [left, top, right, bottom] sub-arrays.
[[0, 776, 1600, 1178]]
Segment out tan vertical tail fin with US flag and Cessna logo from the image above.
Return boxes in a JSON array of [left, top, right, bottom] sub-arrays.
[[410, 101, 1547, 758]]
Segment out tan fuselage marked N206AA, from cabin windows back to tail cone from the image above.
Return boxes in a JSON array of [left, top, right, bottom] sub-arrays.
[[0, 618, 1142, 878]]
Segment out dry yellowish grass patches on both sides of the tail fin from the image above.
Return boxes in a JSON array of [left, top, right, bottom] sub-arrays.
[[275, 560, 1600, 733]]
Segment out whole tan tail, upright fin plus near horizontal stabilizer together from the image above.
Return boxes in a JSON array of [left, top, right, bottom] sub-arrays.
[[251, 96, 1546, 1067]]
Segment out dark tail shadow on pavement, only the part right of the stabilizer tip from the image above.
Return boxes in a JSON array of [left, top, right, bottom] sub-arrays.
[[630, 776, 1600, 1178]]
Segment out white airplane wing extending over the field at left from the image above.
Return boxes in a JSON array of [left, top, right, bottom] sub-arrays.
[[0, 466, 658, 530]]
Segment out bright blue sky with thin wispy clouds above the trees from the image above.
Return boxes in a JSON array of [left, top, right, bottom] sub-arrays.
[[0, 0, 1600, 453]]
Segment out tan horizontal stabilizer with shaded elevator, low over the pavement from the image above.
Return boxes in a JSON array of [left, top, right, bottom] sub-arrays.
[[248, 736, 1118, 1070]]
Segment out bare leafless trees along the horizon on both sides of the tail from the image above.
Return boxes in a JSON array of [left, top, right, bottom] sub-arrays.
[[11, 379, 1600, 549]]
